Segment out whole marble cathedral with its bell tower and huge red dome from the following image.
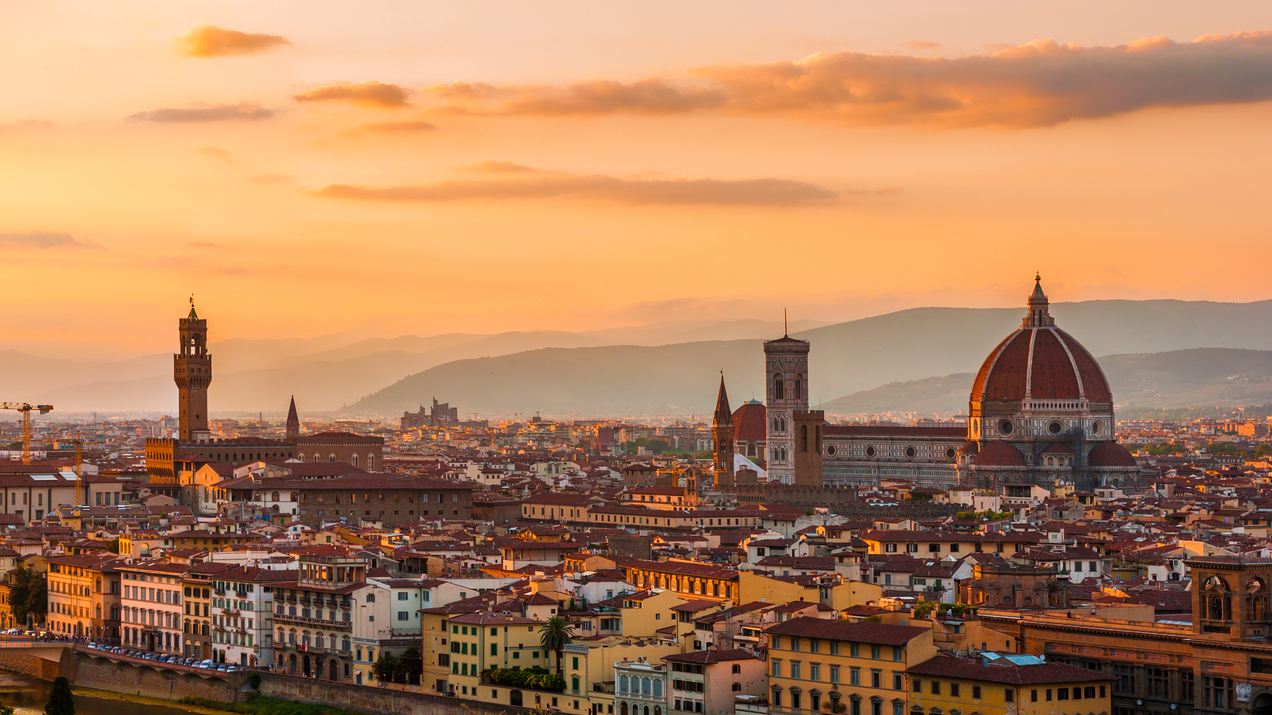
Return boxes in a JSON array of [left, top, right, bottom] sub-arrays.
[[717, 276, 1137, 489]]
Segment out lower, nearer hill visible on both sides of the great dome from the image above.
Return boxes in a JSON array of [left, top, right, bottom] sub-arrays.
[[823, 347, 1272, 416]]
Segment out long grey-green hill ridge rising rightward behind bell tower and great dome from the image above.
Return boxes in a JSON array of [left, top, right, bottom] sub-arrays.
[[347, 300, 1272, 415]]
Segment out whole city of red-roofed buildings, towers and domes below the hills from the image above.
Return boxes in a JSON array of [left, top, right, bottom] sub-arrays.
[[0, 276, 1272, 715]]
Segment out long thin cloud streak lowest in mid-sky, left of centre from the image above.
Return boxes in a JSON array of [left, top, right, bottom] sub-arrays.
[[313, 162, 837, 206]]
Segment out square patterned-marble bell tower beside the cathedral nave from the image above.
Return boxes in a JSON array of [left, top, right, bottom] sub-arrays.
[[764, 324, 809, 483]]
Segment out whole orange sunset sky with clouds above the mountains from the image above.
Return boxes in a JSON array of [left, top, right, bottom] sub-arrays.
[[0, 0, 1272, 356]]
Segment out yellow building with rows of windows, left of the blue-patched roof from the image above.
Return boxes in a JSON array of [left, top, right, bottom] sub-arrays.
[[764, 617, 936, 715]]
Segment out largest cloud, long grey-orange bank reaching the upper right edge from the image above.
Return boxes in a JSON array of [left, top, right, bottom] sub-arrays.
[[427, 32, 1272, 127]]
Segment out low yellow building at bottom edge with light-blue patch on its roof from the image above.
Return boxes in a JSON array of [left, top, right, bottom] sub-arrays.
[[909, 653, 1116, 715]]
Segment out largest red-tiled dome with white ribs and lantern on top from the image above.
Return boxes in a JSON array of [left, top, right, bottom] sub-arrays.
[[971, 273, 1113, 405]]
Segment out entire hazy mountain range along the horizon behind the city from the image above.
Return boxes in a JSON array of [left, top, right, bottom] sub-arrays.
[[12, 300, 1272, 416]]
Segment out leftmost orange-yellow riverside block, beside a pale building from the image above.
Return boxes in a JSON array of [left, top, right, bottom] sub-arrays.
[[46, 553, 120, 642]]
